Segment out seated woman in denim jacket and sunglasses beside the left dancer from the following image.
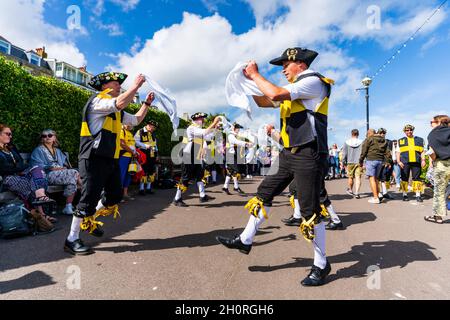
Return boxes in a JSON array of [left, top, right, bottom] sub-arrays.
[[31, 129, 81, 215]]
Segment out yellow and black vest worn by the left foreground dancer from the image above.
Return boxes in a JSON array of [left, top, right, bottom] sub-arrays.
[[79, 89, 123, 159]]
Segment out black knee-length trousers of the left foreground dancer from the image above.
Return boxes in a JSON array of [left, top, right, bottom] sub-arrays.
[[77, 155, 122, 217]]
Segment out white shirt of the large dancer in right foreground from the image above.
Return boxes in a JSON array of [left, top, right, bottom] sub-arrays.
[[284, 70, 328, 136]]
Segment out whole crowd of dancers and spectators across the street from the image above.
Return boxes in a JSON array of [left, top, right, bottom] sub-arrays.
[[0, 48, 450, 286]]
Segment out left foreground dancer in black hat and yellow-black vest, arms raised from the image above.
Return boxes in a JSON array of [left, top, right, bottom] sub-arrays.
[[64, 72, 154, 255]]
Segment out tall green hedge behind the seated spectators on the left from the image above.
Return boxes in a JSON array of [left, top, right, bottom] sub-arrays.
[[0, 56, 187, 165]]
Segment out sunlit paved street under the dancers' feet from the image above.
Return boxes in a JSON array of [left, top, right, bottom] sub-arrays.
[[0, 178, 450, 300]]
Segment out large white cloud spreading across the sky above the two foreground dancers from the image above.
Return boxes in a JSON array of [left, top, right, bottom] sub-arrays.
[[110, 0, 445, 136]]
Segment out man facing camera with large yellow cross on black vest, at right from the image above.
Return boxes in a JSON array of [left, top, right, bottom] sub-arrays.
[[397, 124, 426, 202]]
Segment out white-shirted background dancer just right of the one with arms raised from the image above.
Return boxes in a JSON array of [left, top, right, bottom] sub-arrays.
[[222, 123, 251, 195]]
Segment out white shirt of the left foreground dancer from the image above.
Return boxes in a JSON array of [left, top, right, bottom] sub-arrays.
[[87, 97, 139, 136]]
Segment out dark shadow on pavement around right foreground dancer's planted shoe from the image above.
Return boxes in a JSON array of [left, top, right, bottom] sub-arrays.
[[248, 240, 439, 282]]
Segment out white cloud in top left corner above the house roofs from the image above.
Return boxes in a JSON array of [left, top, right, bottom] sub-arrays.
[[0, 0, 87, 66]]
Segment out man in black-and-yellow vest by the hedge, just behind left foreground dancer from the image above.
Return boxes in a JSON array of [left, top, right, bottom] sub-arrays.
[[134, 120, 158, 195]]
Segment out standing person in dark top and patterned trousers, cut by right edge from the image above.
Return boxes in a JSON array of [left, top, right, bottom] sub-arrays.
[[424, 115, 450, 224]]
